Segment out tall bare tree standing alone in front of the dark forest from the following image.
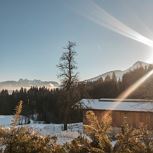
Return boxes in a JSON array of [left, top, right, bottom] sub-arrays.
[[57, 41, 78, 130]]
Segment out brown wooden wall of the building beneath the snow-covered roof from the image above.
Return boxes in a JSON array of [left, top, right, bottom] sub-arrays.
[[83, 110, 153, 129]]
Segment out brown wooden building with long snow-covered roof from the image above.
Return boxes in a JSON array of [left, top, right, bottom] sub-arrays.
[[81, 99, 153, 129]]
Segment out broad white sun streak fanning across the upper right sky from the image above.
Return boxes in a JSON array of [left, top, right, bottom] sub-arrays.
[[78, 0, 153, 47]]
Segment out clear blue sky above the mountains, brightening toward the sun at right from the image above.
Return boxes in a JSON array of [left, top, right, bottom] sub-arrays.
[[0, 0, 153, 81]]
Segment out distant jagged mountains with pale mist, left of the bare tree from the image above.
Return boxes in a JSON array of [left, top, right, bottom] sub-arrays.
[[0, 79, 59, 92]]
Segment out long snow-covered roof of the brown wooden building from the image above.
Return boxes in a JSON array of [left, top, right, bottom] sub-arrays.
[[81, 99, 153, 112]]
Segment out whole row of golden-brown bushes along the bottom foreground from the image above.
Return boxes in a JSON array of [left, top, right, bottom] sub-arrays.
[[0, 111, 153, 153]]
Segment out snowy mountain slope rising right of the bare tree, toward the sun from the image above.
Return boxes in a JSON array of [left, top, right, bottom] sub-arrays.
[[85, 61, 151, 82]]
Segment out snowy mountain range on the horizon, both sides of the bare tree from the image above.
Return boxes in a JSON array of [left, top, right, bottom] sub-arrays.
[[0, 61, 150, 93]]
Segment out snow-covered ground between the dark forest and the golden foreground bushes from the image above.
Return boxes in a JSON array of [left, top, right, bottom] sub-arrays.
[[0, 115, 83, 144]]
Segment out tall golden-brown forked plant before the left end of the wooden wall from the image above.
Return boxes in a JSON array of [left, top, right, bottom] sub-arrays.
[[85, 111, 112, 153]]
